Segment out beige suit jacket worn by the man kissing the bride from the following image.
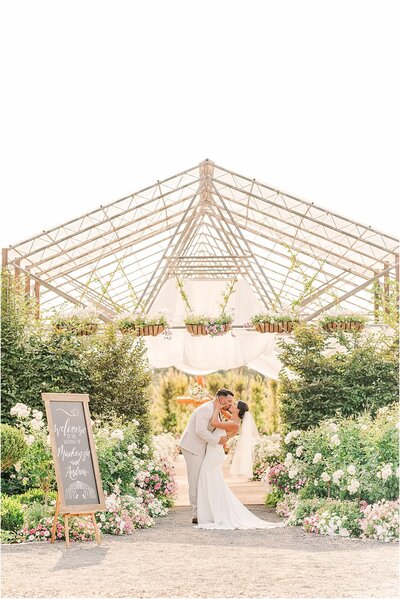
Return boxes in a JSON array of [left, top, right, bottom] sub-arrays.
[[179, 401, 220, 455]]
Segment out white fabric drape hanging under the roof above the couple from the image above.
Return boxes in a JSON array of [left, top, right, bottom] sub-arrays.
[[145, 279, 281, 378]]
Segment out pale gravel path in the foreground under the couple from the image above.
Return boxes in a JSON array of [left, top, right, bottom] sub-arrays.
[[2, 506, 398, 598]]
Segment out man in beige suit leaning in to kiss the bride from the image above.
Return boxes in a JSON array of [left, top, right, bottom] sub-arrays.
[[179, 387, 234, 524]]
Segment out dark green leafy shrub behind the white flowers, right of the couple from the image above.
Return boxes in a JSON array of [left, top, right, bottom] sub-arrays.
[[278, 325, 398, 431]]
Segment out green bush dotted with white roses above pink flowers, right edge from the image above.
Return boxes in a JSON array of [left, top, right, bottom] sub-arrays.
[[281, 406, 399, 503]]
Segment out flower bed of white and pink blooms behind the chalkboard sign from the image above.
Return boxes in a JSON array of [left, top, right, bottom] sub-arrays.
[[2, 404, 178, 543]]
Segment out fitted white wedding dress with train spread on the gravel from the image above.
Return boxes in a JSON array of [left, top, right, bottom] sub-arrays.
[[197, 429, 285, 530]]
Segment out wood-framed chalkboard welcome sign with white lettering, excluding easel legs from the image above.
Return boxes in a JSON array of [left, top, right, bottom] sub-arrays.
[[42, 393, 105, 514]]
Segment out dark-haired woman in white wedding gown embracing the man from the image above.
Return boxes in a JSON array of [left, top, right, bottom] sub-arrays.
[[197, 400, 284, 530]]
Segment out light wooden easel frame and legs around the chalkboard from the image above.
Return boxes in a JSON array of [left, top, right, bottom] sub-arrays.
[[42, 393, 107, 547]]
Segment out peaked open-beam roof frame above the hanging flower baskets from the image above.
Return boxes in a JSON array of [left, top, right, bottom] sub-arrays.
[[3, 160, 399, 320]]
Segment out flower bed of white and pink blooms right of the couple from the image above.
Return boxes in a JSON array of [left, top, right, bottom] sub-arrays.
[[255, 406, 399, 542]]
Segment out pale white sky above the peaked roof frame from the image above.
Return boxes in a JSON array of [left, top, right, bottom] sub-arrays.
[[0, 0, 400, 247]]
